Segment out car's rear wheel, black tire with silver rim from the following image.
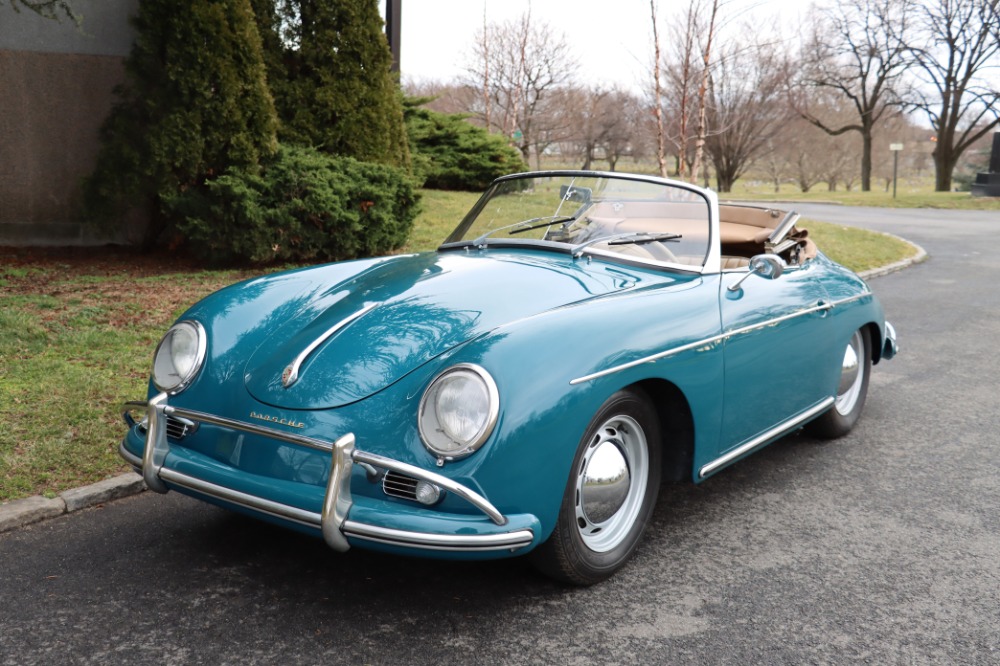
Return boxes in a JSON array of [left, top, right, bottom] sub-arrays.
[[806, 327, 872, 439]]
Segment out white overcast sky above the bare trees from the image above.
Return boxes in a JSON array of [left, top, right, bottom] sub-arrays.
[[386, 0, 809, 88]]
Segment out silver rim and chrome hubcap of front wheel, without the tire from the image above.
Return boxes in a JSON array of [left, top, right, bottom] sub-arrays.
[[576, 416, 649, 553]]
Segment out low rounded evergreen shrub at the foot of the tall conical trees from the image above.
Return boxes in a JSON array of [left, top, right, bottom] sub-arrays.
[[168, 145, 419, 264]]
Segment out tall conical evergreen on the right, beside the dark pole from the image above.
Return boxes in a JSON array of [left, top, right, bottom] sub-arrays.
[[255, 0, 409, 167]]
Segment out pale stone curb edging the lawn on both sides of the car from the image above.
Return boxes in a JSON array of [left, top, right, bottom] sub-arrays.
[[0, 232, 928, 533]]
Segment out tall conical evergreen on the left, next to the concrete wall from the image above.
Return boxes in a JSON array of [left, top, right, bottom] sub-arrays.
[[84, 0, 277, 245]]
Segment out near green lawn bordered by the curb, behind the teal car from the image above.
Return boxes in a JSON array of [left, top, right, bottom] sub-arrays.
[[0, 191, 912, 500]]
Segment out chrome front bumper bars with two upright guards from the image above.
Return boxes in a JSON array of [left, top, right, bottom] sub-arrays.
[[119, 393, 534, 552]]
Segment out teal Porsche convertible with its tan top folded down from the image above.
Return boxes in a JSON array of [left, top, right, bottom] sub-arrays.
[[120, 171, 896, 584]]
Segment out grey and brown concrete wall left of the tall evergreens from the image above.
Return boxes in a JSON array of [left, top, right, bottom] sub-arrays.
[[0, 0, 138, 245]]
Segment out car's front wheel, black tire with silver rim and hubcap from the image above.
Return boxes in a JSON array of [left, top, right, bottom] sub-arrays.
[[532, 391, 662, 585]]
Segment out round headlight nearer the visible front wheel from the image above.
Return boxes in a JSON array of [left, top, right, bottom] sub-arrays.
[[419, 363, 500, 460]]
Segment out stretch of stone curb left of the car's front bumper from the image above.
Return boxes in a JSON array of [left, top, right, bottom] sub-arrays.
[[0, 472, 146, 532]]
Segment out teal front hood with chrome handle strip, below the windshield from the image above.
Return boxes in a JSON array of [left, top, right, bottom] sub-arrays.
[[244, 251, 636, 409]]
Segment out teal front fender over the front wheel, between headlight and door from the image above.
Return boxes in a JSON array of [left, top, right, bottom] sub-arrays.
[[439, 277, 723, 538]]
